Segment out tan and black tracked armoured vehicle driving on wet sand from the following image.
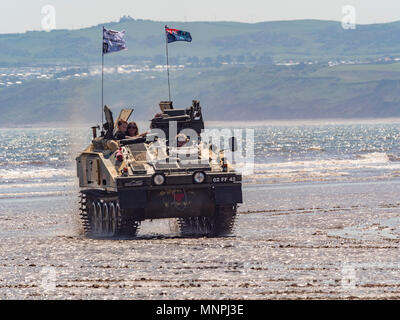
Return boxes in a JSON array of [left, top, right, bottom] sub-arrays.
[[76, 101, 242, 237]]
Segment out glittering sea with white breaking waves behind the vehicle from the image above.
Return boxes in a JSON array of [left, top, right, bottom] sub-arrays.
[[0, 120, 400, 201]]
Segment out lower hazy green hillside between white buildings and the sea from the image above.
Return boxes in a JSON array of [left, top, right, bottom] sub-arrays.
[[0, 63, 400, 126]]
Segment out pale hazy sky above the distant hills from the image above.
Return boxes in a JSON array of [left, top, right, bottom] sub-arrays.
[[0, 0, 400, 33]]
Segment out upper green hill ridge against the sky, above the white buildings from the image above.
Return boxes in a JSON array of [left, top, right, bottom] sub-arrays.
[[0, 19, 400, 66]]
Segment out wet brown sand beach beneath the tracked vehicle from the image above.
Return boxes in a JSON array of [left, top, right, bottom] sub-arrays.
[[0, 181, 400, 299]]
